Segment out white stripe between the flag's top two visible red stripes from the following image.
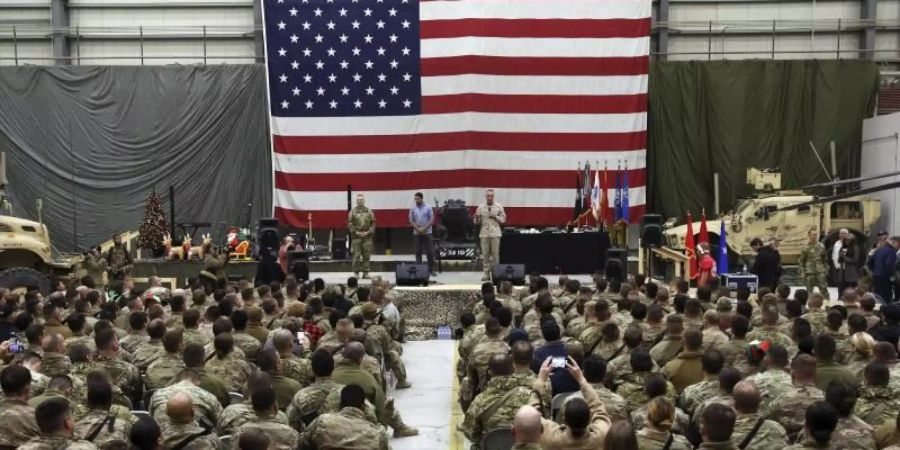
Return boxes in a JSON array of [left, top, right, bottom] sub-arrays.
[[421, 36, 650, 58]]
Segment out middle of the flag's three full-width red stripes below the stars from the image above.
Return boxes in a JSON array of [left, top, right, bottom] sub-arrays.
[[275, 167, 646, 191]]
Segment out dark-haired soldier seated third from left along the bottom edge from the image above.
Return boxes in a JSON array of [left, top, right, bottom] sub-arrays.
[[75, 380, 137, 450]]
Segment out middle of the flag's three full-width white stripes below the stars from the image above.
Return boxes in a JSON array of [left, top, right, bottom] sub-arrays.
[[274, 149, 647, 173]]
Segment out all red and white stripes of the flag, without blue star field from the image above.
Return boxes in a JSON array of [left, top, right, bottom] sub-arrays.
[[272, 0, 651, 228]]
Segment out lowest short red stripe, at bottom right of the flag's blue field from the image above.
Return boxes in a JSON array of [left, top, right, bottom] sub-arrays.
[[422, 94, 647, 114]]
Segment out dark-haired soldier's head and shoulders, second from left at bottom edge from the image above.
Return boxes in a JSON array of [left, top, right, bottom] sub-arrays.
[[18, 398, 97, 450]]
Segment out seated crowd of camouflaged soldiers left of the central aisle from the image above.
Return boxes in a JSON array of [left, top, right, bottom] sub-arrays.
[[0, 276, 418, 450]]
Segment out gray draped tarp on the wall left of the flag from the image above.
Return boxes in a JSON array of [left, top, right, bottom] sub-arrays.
[[0, 65, 272, 251]]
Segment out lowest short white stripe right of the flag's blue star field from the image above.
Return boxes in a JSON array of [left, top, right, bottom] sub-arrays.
[[422, 74, 647, 96]]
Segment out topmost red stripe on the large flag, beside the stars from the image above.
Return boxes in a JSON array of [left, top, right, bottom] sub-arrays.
[[419, 18, 650, 39]]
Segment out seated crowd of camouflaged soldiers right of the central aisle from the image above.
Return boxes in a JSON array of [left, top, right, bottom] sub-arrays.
[[457, 271, 900, 450]]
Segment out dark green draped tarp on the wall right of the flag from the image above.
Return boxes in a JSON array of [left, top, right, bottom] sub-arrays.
[[647, 60, 878, 219]]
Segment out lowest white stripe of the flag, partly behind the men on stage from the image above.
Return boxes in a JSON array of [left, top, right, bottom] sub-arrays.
[[274, 186, 646, 210]]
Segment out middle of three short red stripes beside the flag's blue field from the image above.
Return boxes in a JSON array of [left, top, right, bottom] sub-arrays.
[[420, 55, 650, 77]]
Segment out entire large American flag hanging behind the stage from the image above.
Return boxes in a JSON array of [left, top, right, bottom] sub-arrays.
[[264, 0, 651, 228]]
